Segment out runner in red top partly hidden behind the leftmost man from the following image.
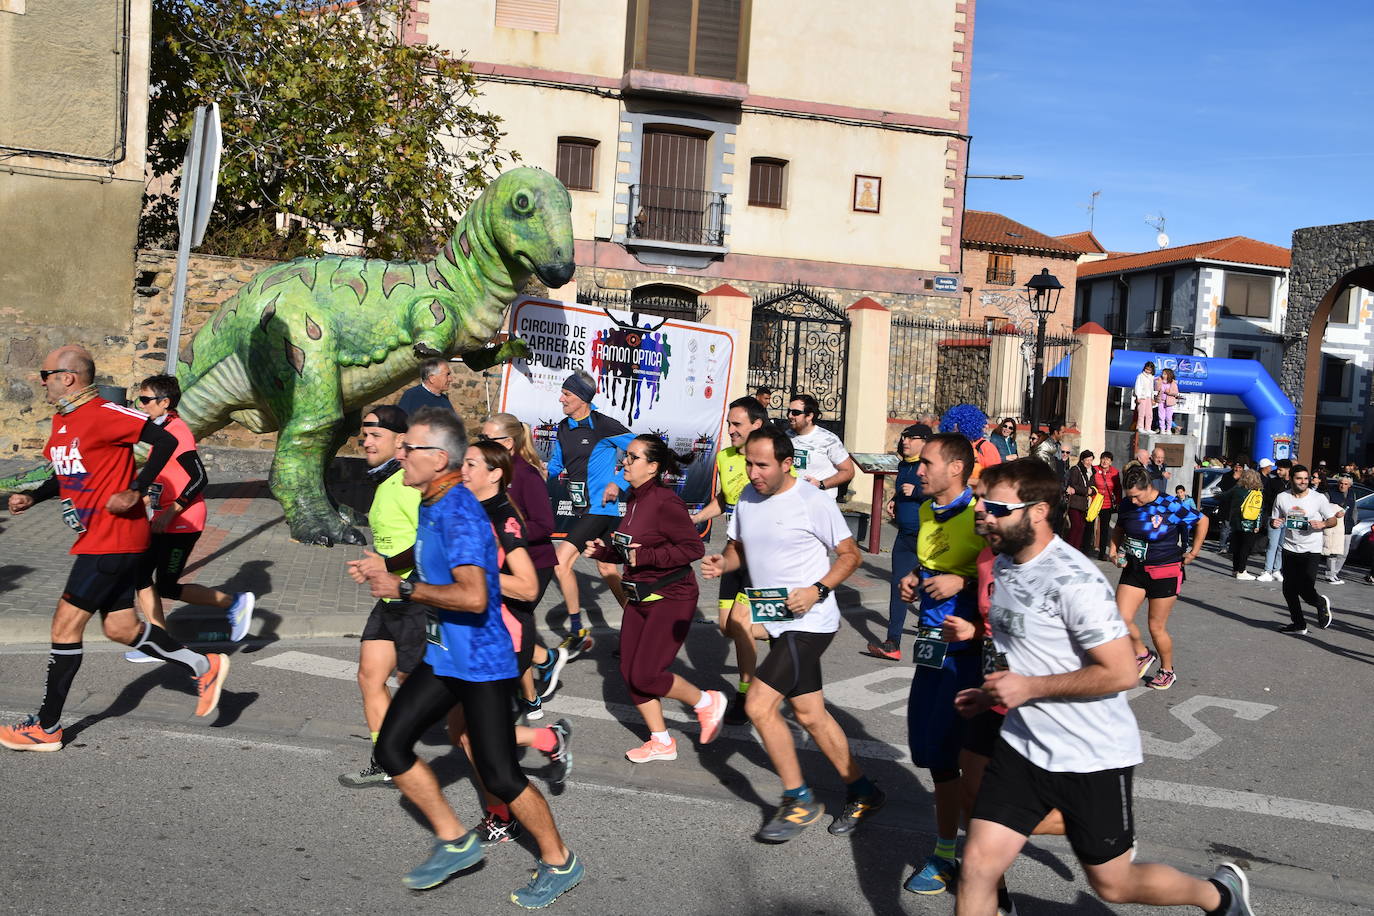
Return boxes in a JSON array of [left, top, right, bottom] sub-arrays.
[[124, 375, 254, 662]]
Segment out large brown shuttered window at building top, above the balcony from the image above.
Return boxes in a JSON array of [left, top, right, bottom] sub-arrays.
[[625, 0, 750, 82]]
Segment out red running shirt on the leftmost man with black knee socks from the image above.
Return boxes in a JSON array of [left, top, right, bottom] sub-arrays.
[[43, 397, 150, 555]]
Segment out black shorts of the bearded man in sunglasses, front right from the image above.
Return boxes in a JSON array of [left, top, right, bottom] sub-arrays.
[[973, 739, 1135, 865]]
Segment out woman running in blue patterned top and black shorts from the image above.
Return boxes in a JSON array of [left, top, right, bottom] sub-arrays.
[[1107, 466, 1208, 691]]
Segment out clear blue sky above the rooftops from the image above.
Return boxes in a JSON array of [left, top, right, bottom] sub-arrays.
[[967, 0, 1374, 251]]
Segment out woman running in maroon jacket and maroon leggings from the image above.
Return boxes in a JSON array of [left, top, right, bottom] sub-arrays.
[[585, 435, 725, 764]]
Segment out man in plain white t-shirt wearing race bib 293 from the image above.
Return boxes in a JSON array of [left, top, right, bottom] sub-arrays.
[[701, 427, 886, 843]]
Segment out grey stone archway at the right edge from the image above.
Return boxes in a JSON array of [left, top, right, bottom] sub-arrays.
[[1279, 220, 1374, 464]]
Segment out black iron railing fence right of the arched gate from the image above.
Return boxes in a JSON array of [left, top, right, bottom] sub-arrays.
[[888, 317, 1077, 423]]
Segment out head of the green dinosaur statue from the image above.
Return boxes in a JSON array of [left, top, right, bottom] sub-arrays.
[[482, 168, 576, 288]]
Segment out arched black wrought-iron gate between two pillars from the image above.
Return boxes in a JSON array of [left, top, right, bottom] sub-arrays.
[[749, 283, 849, 437]]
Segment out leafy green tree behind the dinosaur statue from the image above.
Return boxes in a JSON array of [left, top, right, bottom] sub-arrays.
[[140, 0, 517, 258]]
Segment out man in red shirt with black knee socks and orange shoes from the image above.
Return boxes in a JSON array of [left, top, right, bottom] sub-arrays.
[[0, 346, 229, 751]]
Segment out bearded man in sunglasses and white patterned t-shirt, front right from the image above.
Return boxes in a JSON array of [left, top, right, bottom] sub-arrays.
[[955, 461, 1253, 916]]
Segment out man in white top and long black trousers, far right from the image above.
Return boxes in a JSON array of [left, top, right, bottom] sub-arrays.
[[1270, 464, 1345, 636]]
